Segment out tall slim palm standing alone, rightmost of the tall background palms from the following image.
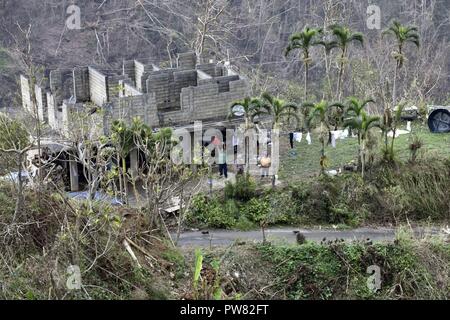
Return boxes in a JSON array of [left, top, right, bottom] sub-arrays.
[[383, 21, 420, 107]]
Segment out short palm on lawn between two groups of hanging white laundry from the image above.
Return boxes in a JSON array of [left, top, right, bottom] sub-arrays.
[[302, 100, 344, 173]]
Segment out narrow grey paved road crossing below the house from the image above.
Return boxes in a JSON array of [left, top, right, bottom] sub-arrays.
[[174, 228, 439, 247]]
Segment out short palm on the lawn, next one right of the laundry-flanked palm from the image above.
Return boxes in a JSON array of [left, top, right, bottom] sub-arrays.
[[345, 111, 380, 178]]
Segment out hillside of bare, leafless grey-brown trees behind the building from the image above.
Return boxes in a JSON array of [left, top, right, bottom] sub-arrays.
[[0, 0, 450, 108]]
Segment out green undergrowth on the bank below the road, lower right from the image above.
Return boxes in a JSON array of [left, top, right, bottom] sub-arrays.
[[257, 238, 450, 299]]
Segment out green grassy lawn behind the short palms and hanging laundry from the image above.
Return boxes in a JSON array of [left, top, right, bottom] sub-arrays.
[[279, 123, 450, 181]]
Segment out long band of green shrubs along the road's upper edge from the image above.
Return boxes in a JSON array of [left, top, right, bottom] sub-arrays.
[[191, 160, 450, 229]]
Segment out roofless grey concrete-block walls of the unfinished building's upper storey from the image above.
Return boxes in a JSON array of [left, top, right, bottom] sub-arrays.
[[20, 53, 250, 191]]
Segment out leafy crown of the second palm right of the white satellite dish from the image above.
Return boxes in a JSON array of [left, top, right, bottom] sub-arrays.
[[255, 92, 300, 130]]
